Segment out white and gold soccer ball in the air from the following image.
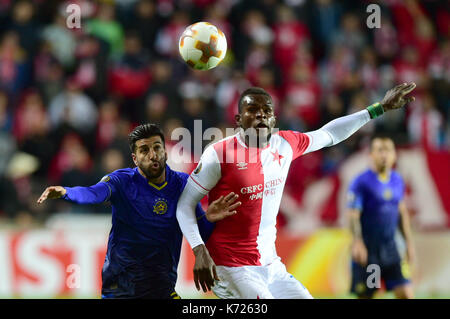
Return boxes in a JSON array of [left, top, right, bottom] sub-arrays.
[[178, 22, 227, 70]]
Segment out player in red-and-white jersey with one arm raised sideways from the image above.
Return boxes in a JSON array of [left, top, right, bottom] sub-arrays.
[[177, 83, 415, 298]]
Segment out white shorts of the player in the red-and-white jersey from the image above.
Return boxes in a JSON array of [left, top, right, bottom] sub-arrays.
[[212, 259, 313, 299]]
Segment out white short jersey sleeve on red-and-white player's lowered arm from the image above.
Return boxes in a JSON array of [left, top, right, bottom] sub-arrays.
[[188, 146, 221, 195]]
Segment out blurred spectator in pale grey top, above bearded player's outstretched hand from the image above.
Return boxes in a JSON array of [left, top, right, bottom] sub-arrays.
[[49, 79, 98, 133]]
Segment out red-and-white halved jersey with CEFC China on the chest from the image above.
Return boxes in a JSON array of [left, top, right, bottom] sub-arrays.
[[189, 131, 310, 267]]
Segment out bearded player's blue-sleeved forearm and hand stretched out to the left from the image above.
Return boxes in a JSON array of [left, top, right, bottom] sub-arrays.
[[37, 182, 112, 204]]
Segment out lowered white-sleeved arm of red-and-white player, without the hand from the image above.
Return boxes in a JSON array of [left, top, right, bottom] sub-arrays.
[[176, 181, 204, 249]]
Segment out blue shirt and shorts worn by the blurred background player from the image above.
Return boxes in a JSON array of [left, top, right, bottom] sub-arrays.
[[348, 169, 409, 297]]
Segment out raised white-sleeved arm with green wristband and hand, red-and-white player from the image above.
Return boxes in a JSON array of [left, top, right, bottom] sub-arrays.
[[305, 83, 416, 154]]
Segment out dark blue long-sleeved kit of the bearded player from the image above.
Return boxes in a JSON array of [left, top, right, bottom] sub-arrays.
[[63, 165, 214, 299]]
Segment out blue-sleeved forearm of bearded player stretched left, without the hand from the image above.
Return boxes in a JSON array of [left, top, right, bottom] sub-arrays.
[[62, 183, 111, 204]]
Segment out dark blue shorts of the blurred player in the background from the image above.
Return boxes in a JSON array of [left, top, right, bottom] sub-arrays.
[[351, 261, 411, 298]]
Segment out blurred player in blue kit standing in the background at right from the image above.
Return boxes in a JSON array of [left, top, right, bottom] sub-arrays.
[[348, 136, 414, 298]]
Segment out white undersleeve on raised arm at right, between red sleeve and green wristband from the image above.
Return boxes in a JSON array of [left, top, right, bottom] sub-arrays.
[[305, 110, 370, 153]]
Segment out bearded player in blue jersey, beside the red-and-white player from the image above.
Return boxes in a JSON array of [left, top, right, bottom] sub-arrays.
[[38, 124, 240, 299]]
